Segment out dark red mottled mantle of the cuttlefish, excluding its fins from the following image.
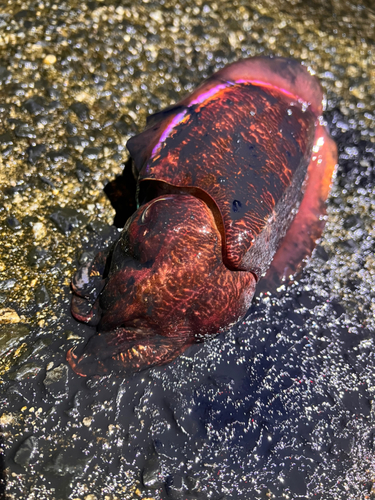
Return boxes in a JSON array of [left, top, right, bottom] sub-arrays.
[[135, 84, 316, 276]]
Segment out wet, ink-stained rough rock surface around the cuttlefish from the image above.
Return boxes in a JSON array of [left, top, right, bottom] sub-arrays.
[[0, 0, 375, 500]]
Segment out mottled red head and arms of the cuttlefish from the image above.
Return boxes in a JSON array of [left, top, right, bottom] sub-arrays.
[[68, 195, 256, 375]]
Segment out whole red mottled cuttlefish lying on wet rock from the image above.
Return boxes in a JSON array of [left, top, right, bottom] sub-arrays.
[[68, 58, 337, 375]]
